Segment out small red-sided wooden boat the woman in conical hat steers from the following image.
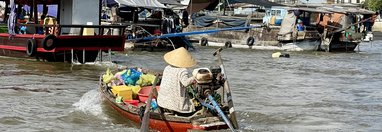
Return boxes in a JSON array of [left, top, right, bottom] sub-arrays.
[[99, 66, 238, 132]]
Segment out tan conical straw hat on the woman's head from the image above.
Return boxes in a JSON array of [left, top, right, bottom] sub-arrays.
[[164, 47, 196, 68]]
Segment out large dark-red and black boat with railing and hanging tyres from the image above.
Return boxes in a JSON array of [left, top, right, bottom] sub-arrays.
[[0, 0, 125, 63]]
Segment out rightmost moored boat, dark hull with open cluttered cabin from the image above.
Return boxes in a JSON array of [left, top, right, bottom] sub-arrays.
[[318, 7, 375, 52]]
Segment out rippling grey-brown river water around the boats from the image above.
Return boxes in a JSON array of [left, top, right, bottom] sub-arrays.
[[0, 41, 382, 132]]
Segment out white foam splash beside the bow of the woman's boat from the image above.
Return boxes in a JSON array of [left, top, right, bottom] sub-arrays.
[[73, 89, 107, 120]]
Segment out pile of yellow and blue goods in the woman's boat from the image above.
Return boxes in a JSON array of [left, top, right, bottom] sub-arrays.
[[102, 68, 155, 102]]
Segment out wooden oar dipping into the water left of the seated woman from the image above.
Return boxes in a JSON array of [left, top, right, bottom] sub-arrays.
[[141, 74, 159, 132]]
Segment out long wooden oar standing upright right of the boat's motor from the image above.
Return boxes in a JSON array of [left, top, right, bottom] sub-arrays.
[[213, 48, 239, 129]]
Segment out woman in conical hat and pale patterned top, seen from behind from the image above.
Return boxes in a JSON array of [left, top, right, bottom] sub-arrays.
[[157, 47, 196, 113]]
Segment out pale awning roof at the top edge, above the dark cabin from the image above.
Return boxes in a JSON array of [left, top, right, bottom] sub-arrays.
[[115, 0, 167, 8]]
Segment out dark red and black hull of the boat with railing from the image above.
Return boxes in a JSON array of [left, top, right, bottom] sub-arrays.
[[0, 33, 125, 62]]
